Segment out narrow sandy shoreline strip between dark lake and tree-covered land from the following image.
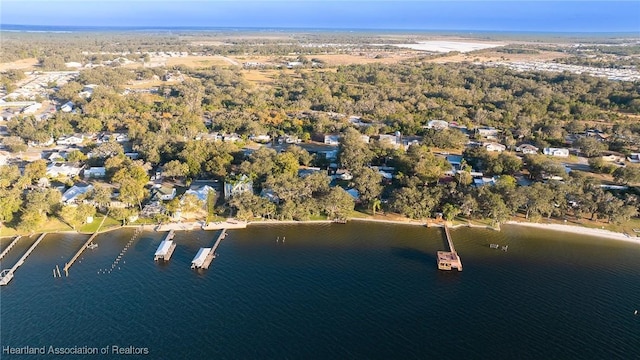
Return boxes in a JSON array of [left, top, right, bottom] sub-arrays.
[[0, 218, 640, 244]]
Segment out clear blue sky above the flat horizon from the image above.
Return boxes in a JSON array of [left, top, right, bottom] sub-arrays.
[[0, 0, 640, 35]]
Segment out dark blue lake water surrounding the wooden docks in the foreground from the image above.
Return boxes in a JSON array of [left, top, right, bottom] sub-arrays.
[[0, 222, 640, 359]]
